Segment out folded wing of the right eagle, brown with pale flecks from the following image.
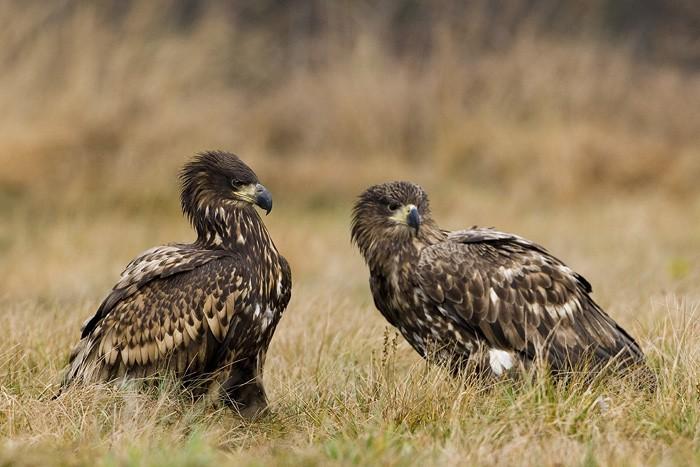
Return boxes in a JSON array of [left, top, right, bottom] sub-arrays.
[[417, 228, 642, 369]]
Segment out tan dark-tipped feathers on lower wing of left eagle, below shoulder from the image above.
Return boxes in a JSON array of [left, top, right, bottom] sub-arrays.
[[68, 257, 248, 380]]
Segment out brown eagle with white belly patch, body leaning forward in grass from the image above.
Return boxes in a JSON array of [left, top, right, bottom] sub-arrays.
[[352, 182, 644, 376]]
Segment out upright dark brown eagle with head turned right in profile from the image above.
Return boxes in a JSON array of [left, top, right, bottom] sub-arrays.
[[58, 152, 292, 415]]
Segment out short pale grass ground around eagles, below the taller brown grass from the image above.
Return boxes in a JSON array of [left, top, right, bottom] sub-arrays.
[[0, 188, 700, 465]]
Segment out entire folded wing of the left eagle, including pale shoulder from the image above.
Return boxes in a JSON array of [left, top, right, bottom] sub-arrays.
[[65, 249, 252, 382]]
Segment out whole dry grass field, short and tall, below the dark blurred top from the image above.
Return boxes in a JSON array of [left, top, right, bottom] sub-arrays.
[[0, 3, 700, 466]]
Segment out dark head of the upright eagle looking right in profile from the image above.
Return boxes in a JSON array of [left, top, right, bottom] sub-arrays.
[[180, 151, 272, 226]]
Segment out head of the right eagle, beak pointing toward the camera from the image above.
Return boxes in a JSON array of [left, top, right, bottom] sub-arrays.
[[351, 182, 430, 260]]
